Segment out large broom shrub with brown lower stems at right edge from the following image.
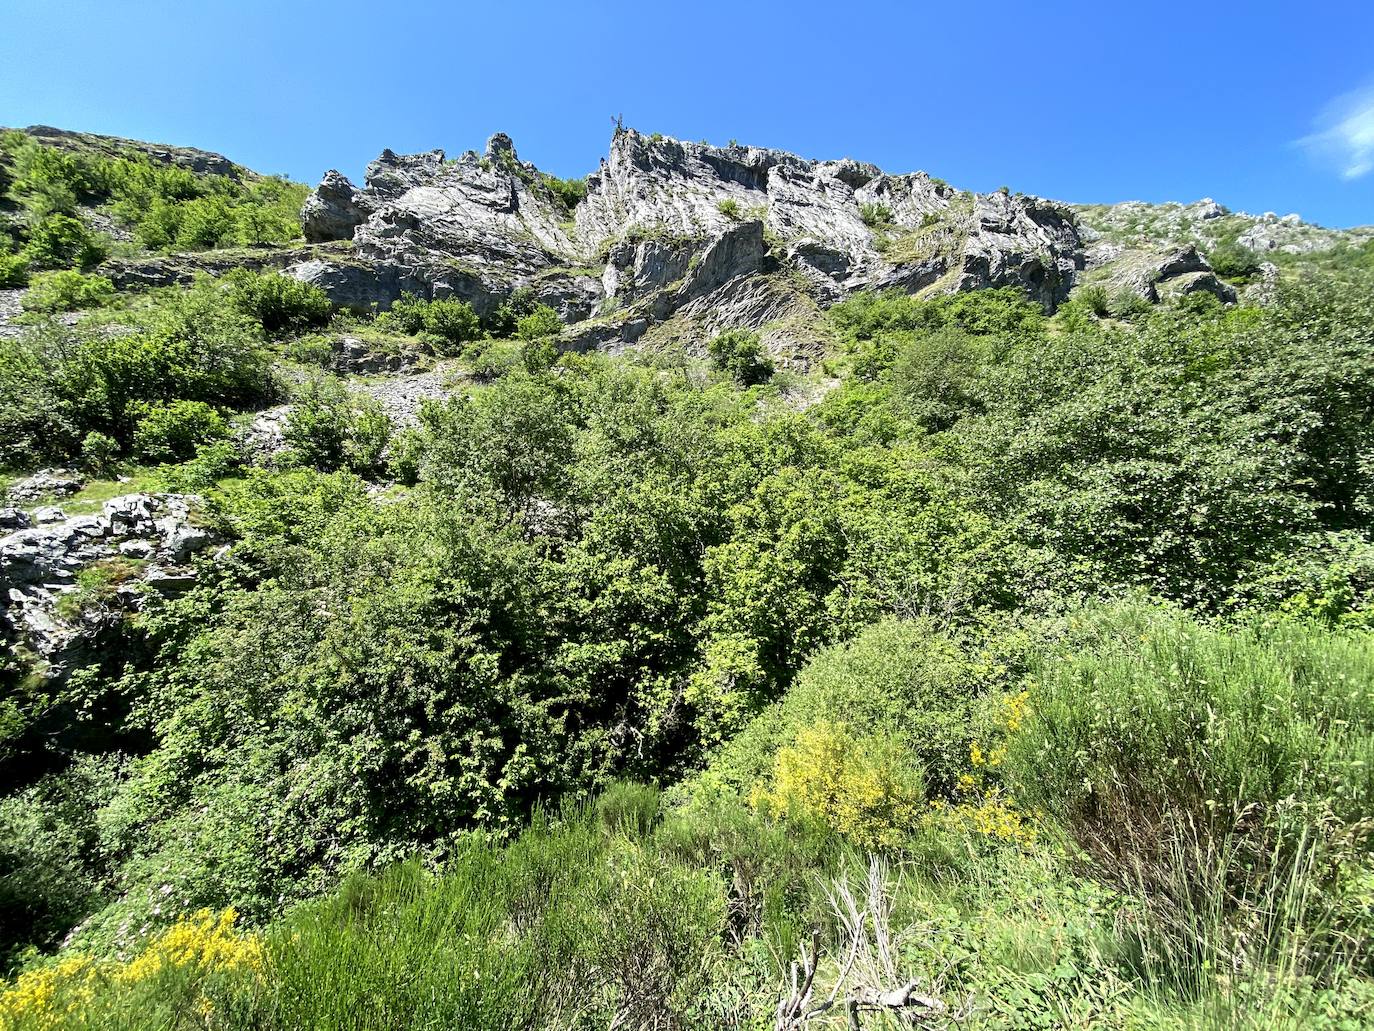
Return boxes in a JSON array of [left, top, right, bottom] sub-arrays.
[[1006, 605, 1374, 962]]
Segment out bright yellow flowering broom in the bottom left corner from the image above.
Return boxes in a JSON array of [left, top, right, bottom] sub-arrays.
[[0, 909, 264, 1031]]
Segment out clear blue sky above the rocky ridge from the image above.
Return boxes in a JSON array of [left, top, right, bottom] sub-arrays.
[[0, 0, 1374, 225]]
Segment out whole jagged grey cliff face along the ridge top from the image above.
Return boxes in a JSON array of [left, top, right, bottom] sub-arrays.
[[290, 129, 1084, 349]]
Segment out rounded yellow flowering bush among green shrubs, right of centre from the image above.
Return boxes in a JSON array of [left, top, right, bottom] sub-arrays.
[[753, 722, 925, 847]]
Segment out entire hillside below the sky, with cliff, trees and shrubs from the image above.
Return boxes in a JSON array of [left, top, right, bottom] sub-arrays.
[[0, 129, 1374, 1031]]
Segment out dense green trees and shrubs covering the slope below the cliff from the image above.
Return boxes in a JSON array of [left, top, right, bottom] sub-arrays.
[[0, 262, 1374, 1027]]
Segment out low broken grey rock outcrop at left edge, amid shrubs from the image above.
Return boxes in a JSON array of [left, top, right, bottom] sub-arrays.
[[0, 494, 213, 678]]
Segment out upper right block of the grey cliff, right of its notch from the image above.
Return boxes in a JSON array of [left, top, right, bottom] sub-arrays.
[[576, 131, 1081, 307]]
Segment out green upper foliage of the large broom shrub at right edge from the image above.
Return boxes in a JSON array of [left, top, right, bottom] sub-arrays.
[[1009, 606, 1374, 850]]
